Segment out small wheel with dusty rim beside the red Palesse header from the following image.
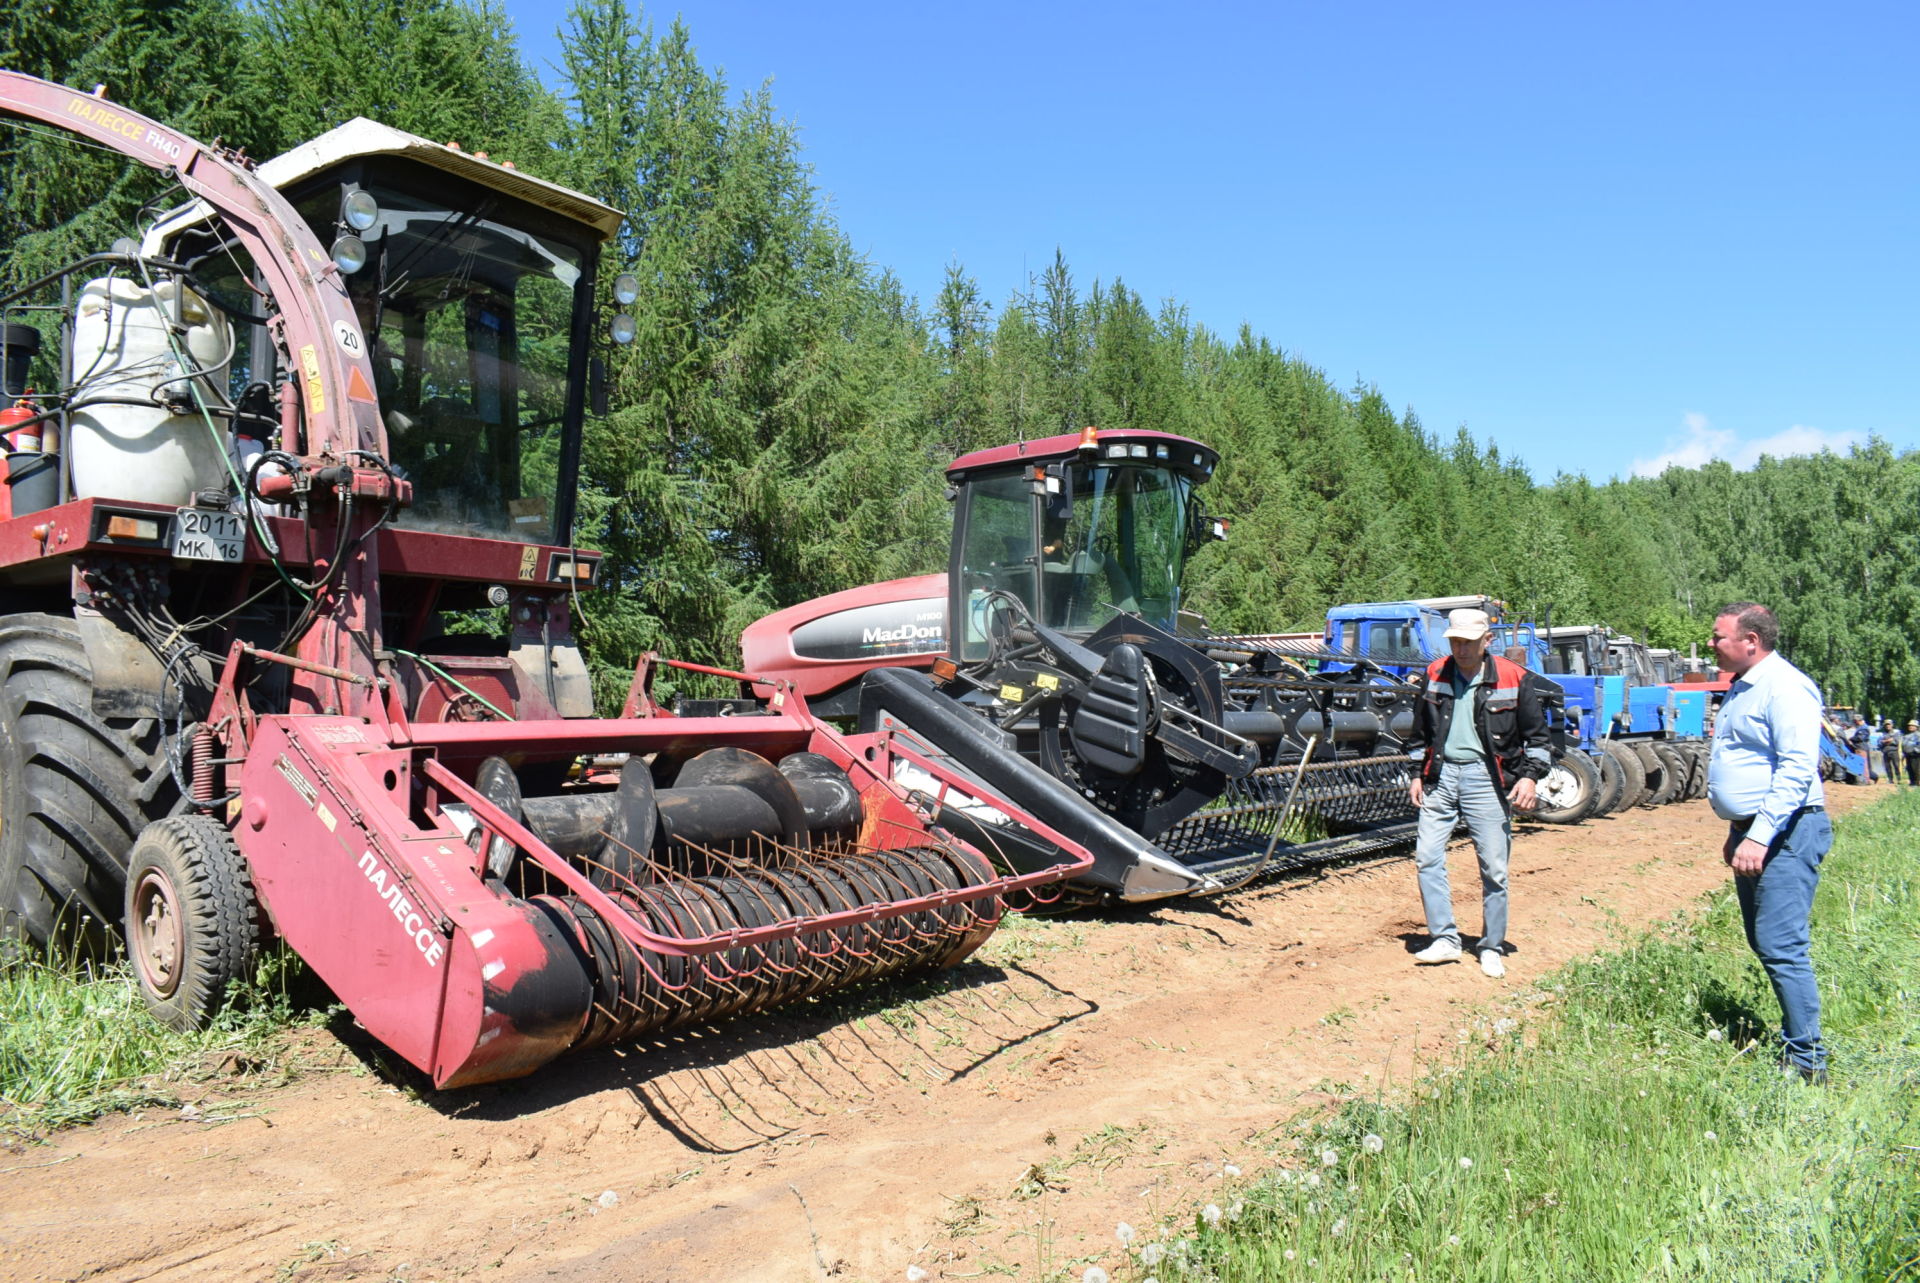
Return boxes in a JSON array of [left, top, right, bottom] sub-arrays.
[[127, 814, 267, 1031]]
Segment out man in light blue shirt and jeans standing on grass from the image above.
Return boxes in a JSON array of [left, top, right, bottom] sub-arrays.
[[1707, 601, 1834, 1083]]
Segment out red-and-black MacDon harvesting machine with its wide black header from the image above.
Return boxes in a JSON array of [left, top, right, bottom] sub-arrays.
[[741, 428, 1436, 901]]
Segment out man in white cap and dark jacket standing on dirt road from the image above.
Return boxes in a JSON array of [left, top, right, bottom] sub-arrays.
[[1407, 609, 1551, 978]]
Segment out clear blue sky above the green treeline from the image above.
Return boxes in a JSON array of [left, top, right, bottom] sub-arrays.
[[507, 0, 1920, 480]]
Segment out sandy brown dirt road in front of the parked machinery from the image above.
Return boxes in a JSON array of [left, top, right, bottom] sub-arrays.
[[0, 787, 1870, 1283]]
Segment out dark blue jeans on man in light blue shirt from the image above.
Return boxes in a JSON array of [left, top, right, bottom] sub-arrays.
[[1734, 811, 1834, 1070]]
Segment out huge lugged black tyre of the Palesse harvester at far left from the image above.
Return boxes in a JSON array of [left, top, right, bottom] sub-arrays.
[[0, 615, 179, 956]]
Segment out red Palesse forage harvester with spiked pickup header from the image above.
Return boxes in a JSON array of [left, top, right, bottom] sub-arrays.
[[0, 73, 1089, 1087]]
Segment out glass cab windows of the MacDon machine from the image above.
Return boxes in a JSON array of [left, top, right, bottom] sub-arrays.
[[958, 463, 1192, 659]]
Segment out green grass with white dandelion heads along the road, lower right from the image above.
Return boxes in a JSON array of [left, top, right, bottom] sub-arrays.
[[1117, 791, 1920, 1283]]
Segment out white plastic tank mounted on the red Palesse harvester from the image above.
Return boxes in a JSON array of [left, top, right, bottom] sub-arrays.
[[67, 277, 234, 505]]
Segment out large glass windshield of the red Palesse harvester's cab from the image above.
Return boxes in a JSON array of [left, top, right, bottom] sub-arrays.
[[300, 181, 588, 544]]
